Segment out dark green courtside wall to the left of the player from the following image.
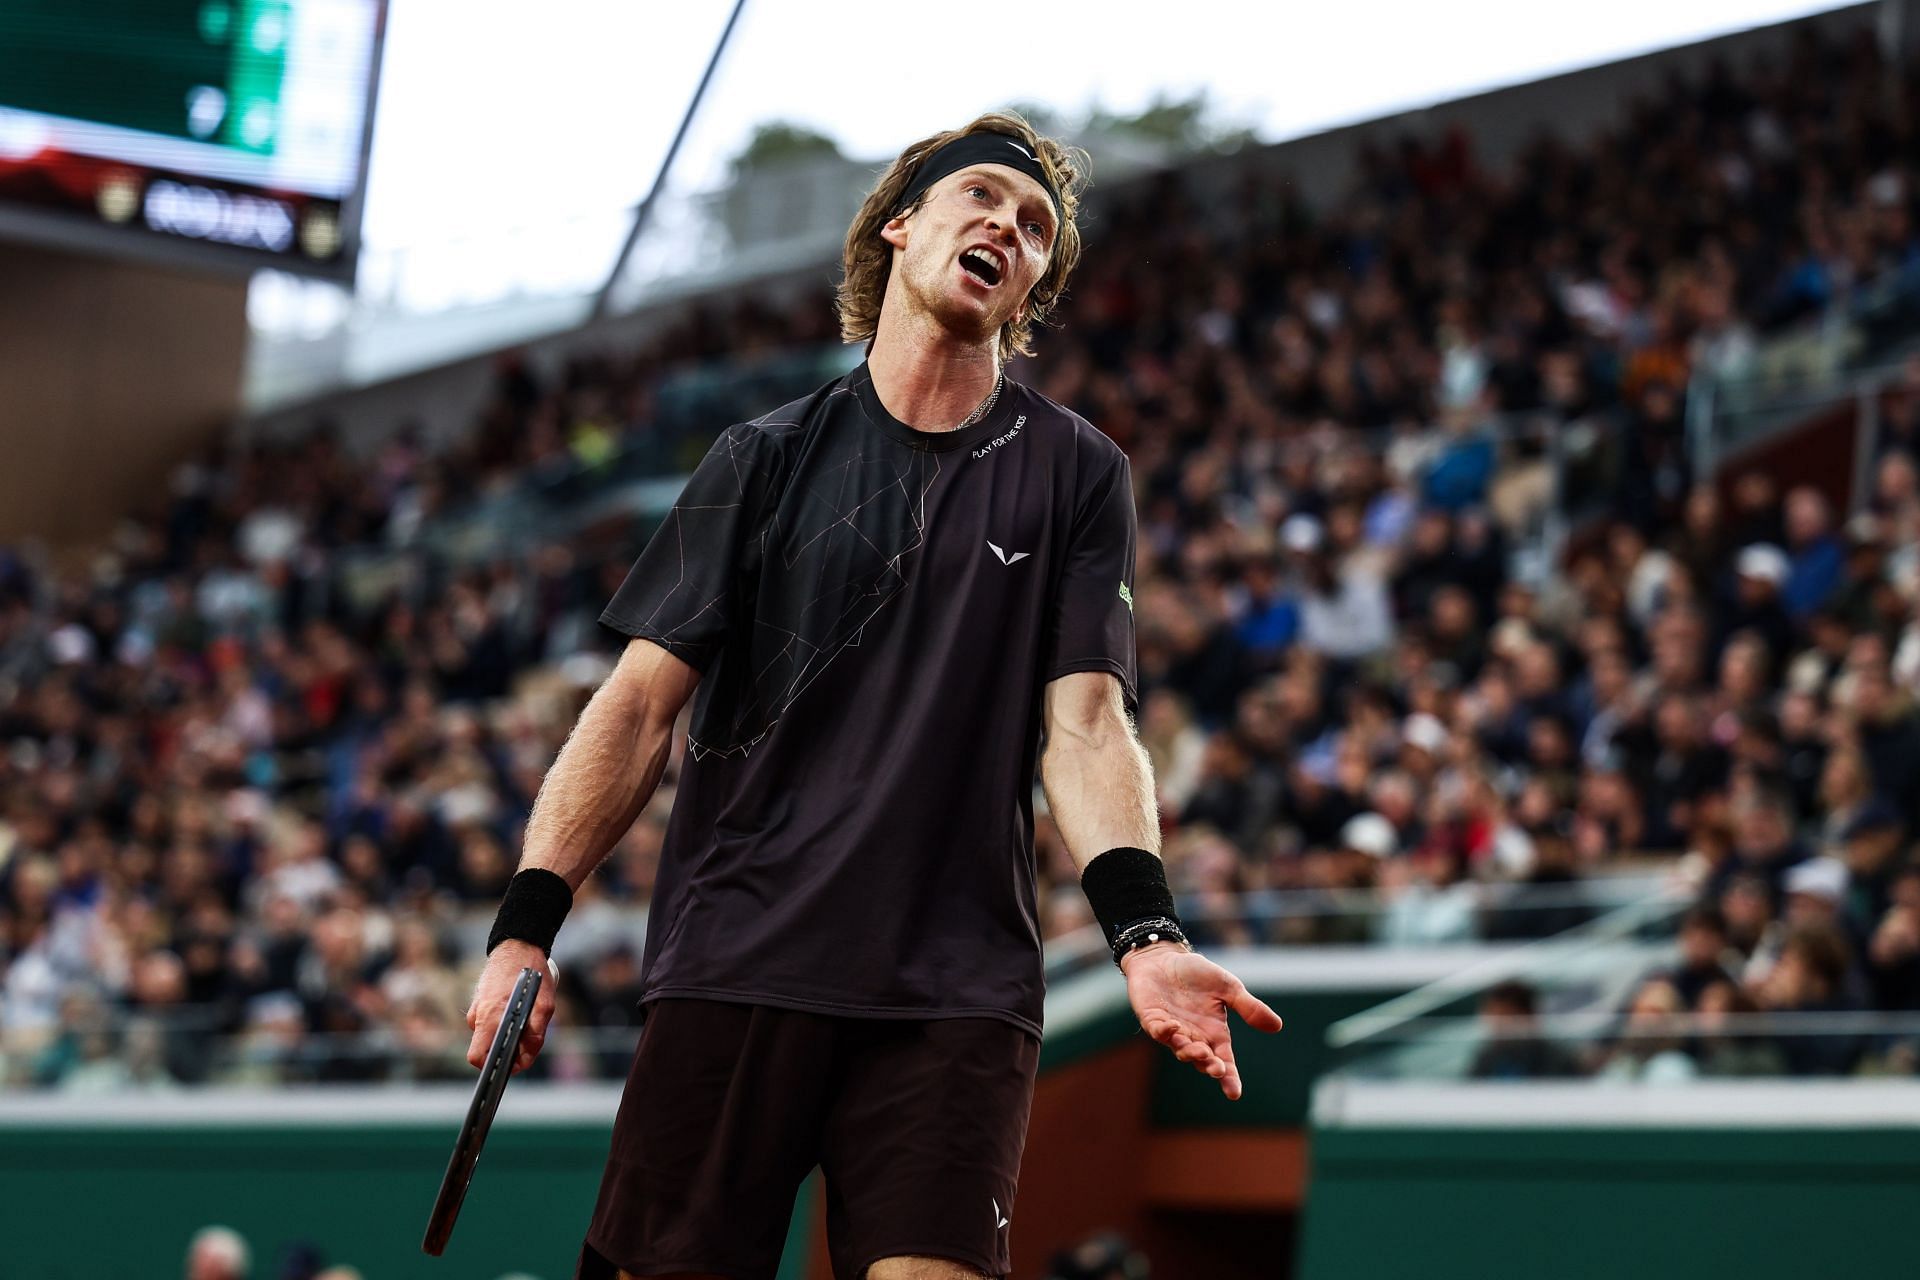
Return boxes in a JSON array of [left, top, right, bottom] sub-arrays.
[[0, 1115, 812, 1280]]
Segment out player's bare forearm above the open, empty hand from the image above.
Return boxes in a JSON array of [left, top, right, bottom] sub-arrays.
[[1041, 714, 1160, 871]]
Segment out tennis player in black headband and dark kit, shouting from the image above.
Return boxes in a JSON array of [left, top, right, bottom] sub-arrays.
[[467, 115, 1281, 1280]]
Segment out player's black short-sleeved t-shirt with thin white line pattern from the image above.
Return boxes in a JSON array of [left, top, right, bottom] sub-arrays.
[[601, 355, 1135, 1034]]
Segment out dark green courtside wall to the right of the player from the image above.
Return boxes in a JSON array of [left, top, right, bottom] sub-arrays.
[[1298, 1128, 1920, 1280]]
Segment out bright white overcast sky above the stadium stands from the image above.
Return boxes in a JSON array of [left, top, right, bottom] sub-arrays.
[[353, 0, 1837, 248]]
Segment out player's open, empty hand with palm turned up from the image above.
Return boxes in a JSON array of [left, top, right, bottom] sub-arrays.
[[1119, 942, 1281, 1098]]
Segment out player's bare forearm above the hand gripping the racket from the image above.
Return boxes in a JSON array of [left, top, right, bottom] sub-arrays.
[[520, 679, 674, 890]]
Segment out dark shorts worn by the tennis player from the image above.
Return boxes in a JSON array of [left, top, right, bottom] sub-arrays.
[[574, 1000, 1041, 1280]]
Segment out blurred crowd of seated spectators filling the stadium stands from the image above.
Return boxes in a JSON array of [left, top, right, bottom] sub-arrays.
[[0, 25, 1920, 1090]]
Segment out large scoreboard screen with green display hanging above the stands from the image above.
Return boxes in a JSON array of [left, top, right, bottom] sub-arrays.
[[0, 0, 386, 278]]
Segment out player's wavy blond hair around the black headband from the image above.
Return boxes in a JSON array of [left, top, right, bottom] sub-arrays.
[[835, 111, 1091, 359]]
